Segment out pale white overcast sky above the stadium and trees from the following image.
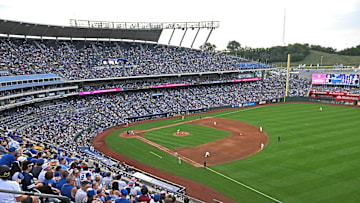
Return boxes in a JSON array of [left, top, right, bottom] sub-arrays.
[[0, 0, 360, 50]]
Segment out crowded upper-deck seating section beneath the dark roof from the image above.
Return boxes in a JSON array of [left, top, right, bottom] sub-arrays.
[[0, 38, 270, 80]]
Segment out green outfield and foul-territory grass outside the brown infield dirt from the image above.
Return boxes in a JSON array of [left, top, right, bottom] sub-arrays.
[[106, 103, 360, 202]]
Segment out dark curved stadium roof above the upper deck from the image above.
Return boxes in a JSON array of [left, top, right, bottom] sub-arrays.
[[0, 19, 162, 42]]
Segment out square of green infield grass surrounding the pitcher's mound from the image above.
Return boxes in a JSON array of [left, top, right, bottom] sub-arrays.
[[144, 123, 231, 149]]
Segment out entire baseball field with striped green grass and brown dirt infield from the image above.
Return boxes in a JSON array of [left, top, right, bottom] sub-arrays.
[[93, 103, 360, 202]]
